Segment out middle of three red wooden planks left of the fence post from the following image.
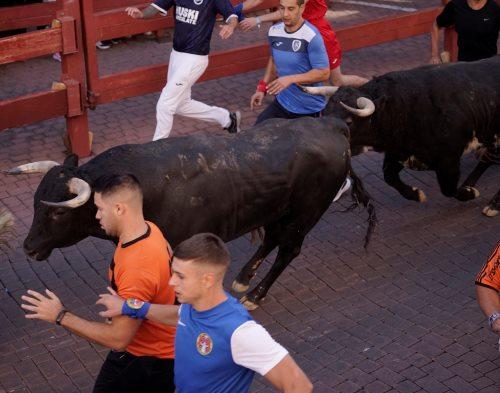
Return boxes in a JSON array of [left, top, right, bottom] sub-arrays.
[[0, 28, 62, 64]]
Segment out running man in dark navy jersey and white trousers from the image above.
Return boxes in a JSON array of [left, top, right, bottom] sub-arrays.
[[126, 0, 241, 141]]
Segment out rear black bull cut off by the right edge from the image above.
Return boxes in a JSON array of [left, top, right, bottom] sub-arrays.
[[304, 56, 500, 216]]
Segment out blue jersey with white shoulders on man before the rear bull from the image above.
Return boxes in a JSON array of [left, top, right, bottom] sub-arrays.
[[268, 21, 329, 115]]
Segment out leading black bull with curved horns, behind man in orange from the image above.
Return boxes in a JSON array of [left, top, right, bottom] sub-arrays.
[[5, 118, 375, 308]]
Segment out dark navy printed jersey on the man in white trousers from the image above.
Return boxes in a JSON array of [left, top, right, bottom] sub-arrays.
[[153, 0, 236, 55]]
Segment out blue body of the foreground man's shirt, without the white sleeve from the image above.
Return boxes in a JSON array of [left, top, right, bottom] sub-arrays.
[[175, 294, 254, 393]]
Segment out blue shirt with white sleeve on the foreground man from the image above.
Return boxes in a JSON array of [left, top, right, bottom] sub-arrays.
[[174, 294, 288, 393]]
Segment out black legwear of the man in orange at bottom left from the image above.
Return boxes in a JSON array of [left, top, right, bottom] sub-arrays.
[[93, 351, 175, 393]]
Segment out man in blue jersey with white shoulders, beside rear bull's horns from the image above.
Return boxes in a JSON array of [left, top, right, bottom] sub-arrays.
[[250, 0, 330, 124]]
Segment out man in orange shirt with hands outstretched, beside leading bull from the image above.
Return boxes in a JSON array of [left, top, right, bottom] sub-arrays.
[[21, 175, 175, 393]]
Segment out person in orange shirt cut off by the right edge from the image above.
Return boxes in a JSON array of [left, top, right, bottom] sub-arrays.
[[476, 242, 500, 333]]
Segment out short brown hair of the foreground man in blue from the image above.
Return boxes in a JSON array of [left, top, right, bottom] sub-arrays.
[[174, 233, 231, 268]]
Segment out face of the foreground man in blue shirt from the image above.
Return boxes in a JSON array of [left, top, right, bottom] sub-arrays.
[[169, 257, 207, 304]]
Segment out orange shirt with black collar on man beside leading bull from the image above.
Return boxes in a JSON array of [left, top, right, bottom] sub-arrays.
[[109, 221, 175, 359]]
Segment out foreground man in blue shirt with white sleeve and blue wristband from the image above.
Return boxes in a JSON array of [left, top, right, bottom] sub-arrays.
[[97, 233, 312, 393]]
